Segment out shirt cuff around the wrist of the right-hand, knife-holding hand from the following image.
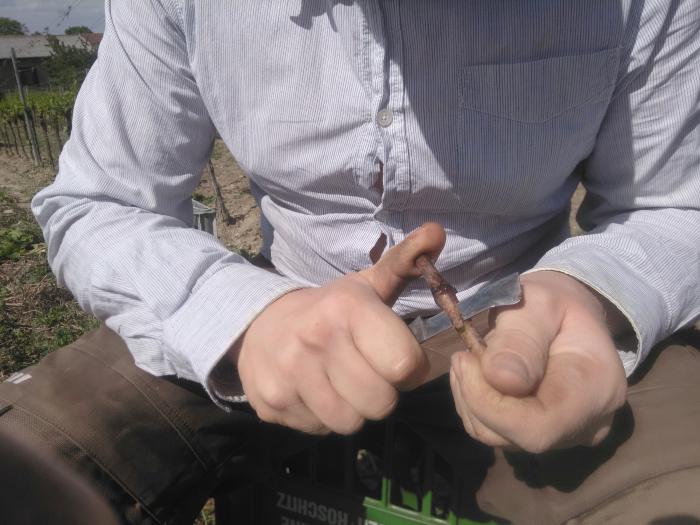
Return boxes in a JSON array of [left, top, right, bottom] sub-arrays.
[[525, 243, 666, 377]]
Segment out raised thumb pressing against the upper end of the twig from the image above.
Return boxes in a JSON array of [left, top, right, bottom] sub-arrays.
[[359, 222, 446, 306]]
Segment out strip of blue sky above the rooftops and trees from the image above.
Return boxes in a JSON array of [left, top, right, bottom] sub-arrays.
[[0, 0, 104, 35]]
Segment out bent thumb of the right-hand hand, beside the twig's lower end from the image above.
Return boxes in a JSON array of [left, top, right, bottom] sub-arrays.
[[481, 298, 560, 397]]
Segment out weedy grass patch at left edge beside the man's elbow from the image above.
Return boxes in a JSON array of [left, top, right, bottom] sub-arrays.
[[0, 191, 99, 380]]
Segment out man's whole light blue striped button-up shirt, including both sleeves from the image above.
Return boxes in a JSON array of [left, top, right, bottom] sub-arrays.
[[33, 0, 700, 402]]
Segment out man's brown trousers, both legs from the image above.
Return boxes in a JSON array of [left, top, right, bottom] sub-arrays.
[[0, 327, 700, 525]]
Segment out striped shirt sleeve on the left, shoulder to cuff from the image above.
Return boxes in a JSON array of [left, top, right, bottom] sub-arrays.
[[32, 0, 300, 400]]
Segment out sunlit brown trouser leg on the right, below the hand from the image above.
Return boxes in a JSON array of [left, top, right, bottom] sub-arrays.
[[478, 332, 700, 524]]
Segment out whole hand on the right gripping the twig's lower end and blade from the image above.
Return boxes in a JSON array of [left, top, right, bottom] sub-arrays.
[[450, 271, 627, 453]]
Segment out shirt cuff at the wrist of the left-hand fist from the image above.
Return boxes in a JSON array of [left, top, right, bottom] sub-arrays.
[[163, 263, 303, 408]]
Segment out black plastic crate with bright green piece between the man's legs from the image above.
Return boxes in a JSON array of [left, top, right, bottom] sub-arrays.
[[216, 420, 495, 525]]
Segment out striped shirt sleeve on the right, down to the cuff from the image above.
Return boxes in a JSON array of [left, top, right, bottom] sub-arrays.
[[535, 1, 700, 375]]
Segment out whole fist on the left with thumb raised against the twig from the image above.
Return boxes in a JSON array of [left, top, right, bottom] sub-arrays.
[[234, 223, 445, 434]]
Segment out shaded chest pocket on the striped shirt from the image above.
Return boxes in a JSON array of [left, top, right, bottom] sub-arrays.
[[454, 49, 618, 214]]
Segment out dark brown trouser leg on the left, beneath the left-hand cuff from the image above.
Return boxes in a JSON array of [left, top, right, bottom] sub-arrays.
[[0, 327, 288, 524]]
